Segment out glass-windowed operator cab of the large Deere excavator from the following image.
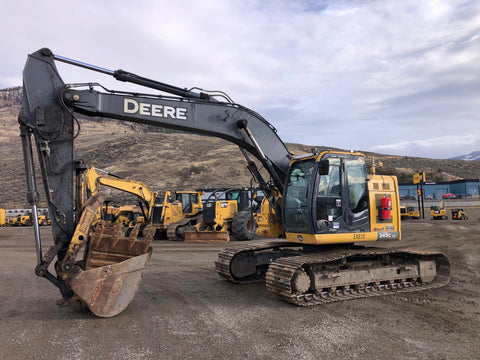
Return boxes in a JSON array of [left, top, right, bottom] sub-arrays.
[[283, 151, 380, 243]]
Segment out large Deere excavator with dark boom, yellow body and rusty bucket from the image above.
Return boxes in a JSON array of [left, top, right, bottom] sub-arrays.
[[19, 48, 450, 317]]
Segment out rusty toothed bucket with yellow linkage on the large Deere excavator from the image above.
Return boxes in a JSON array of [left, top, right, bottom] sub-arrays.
[[61, 195, 155, 317]]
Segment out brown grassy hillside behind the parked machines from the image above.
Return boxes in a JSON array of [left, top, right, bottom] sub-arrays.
[[0, 88, 480, 208]]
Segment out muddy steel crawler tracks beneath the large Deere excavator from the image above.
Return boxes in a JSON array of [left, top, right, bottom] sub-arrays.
[[215, 241, 450, 306]]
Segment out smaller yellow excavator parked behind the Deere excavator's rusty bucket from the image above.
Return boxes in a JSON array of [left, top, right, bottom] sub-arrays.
[[85, 167, 203, 240]]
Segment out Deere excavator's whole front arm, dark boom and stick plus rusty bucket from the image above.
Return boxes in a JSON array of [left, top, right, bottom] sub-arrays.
[[18, 48, 290, 316]]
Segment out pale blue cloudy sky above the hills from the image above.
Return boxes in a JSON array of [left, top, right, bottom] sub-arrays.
[[0, 0, 480, 158]]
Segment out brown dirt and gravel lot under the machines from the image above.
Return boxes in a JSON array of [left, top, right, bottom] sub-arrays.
[[0, 210, 480, 359]]
